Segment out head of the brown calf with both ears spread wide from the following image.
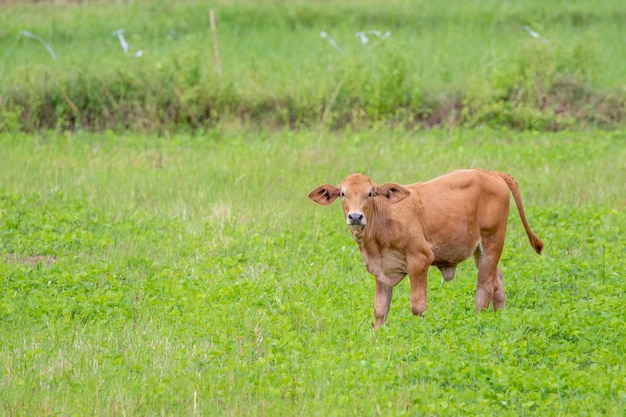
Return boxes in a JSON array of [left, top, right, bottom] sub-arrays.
[[309, 174, 410, 229]]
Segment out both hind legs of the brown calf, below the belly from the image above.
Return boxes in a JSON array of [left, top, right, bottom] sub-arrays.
[[474, 242, 505, 311]]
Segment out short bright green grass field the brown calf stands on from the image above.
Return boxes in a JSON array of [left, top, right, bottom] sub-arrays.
[[0, 126, 626, 416]]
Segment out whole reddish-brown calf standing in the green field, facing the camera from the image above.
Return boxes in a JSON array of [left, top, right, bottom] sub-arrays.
[[309, 169, 543, 328]]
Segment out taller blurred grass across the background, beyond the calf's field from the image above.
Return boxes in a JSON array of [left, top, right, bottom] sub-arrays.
[[0, 0, 626, 134]]
